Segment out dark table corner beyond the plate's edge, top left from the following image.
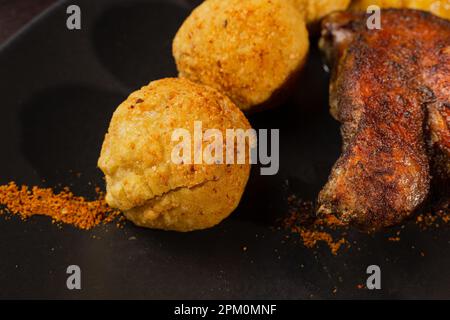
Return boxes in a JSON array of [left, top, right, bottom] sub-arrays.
[[0, 0, 57, 44]]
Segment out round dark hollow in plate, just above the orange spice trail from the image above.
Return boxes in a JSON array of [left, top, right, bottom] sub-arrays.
[[20, 86, 123, 192]]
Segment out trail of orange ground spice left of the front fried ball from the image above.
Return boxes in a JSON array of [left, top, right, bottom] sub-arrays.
[[0, 182, 120, 230]]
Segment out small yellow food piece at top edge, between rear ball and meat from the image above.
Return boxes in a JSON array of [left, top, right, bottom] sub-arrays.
[[291, 0, 351, 24]]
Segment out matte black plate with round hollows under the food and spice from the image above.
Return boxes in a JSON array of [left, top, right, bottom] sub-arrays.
[[0, 0, 450, 299]]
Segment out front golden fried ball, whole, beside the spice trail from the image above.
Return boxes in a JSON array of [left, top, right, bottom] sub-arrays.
[[98, 78, 251, 231]]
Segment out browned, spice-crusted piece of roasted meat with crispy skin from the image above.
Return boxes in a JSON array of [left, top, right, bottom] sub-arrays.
[[318, 9, 450, 231]]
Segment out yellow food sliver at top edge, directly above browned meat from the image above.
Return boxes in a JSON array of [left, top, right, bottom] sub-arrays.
[[351, 0, 450, 20]]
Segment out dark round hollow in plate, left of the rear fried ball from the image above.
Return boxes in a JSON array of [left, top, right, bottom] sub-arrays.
[[93, 0, 192, 89]]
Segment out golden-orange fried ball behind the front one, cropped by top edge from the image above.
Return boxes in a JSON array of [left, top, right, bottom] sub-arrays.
[[173, 0, 309, 111]]
